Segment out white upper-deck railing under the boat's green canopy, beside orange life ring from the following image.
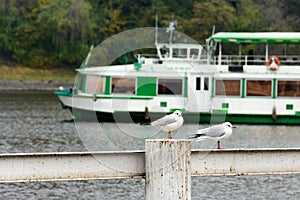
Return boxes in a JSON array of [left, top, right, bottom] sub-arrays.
[[213, 55, 300, 65]]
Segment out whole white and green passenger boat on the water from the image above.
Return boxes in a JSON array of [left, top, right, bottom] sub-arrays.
[[55, 28, 300, 124]]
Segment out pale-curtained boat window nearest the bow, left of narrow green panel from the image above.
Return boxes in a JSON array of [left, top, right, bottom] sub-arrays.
[[85, 75, 105, 94]]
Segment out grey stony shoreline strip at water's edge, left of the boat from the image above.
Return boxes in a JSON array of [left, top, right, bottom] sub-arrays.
[[0, 80, 74, 92]]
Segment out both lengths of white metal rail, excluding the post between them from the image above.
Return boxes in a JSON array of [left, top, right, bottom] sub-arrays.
[[0, 148, 300, 182]]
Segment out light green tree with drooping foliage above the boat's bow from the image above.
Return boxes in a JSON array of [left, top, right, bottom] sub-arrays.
[[37, 0, 96, 65]]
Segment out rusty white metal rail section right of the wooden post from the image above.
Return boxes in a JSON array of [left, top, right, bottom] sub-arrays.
[[191, 148, 300, 176]]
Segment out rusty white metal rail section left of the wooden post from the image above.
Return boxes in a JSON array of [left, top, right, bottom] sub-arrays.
[[0, 151, 145, 182]]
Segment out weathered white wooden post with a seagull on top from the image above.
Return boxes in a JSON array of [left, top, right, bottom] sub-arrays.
[[145, 139, 191, 200]]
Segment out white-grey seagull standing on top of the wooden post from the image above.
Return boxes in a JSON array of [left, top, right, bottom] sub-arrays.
[[151, 110, 184, 139]]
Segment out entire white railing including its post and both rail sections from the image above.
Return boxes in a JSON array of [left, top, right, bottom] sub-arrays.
[[0, 139, 300, 200]]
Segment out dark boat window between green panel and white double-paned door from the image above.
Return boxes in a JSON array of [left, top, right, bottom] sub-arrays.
[[158, 79, 182, 95]]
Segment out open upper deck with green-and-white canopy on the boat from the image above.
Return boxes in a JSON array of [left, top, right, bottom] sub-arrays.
[[208, 32, 300, 66]]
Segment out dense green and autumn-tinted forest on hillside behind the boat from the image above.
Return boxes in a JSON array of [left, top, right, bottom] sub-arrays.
[[0, 0, 300, 68]]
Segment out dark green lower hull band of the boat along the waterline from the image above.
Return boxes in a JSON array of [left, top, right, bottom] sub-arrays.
[[59, 103, 300, 125]]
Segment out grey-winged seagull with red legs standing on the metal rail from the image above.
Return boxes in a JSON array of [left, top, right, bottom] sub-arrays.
[[189, 122, 236, 149]]
